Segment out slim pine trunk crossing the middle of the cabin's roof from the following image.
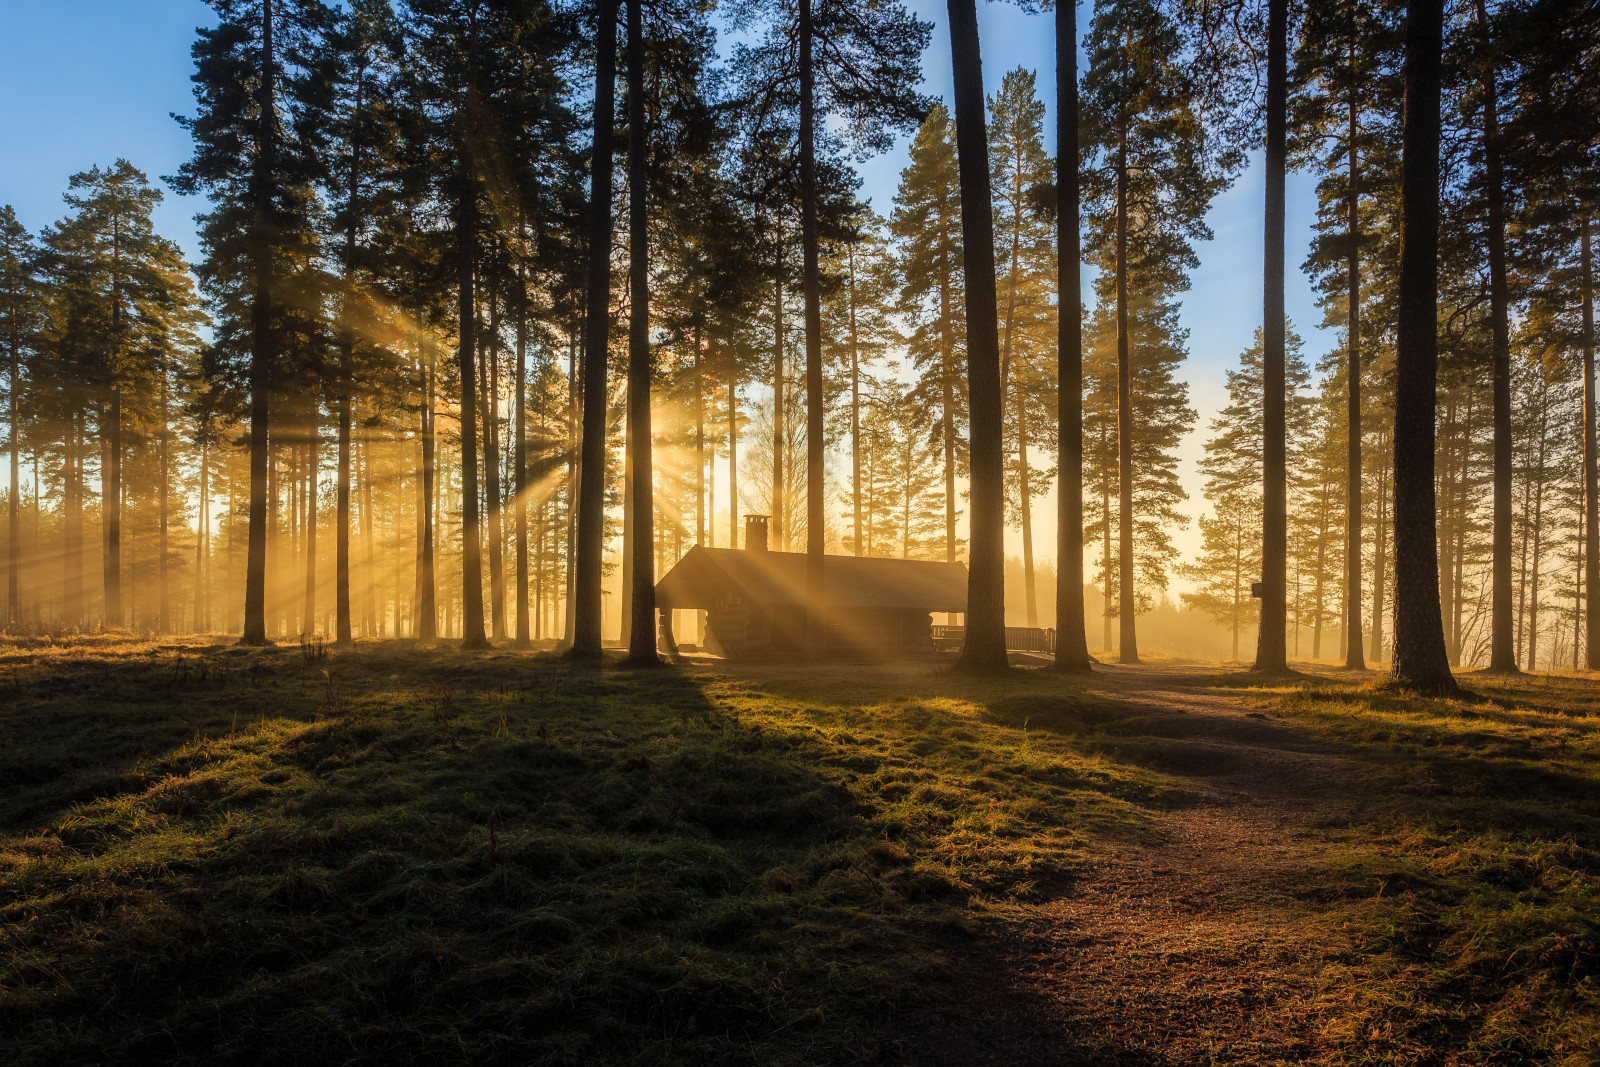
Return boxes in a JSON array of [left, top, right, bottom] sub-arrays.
[[798, 0, 825, 659]]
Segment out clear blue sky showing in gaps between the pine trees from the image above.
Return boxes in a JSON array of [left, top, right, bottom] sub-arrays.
[[0, 0, 1334, 585]]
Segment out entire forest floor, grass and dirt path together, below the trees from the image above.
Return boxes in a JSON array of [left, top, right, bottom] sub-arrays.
[[0, 638, 1600, 1065]]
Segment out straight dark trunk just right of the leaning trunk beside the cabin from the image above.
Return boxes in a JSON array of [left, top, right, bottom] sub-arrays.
[[1056, 3, 1094, 670]]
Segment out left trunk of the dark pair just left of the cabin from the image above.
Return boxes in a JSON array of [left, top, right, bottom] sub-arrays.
[[568, 0, 618, 661]]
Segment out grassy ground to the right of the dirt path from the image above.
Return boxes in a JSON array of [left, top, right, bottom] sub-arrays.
[[1246, 662, 1600, 1064]]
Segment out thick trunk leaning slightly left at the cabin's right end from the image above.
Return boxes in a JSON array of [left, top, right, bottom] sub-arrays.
[[949, 0, 1006, 670]]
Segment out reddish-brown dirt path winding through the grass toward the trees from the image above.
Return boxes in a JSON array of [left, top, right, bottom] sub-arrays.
[[906, 667, 1349, 1067]]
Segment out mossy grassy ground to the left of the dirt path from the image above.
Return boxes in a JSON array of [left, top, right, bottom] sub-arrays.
[[0, 640, 1179, 1064]]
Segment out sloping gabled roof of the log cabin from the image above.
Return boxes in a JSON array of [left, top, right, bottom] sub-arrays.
[[656, 545, 966, 611]]
